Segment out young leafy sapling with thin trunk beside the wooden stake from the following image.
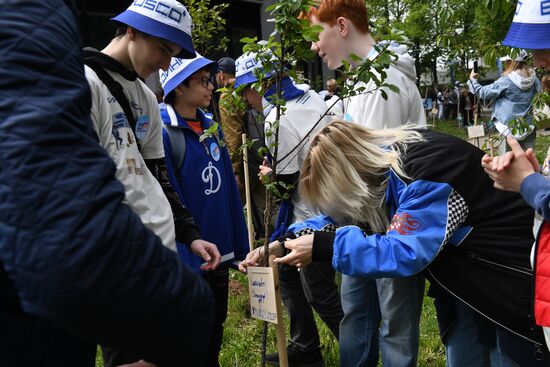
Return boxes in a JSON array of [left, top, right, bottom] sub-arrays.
[[234, 0, 408, 366]]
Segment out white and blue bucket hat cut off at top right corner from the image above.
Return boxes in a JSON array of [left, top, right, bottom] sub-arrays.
[[502, 0, 550, 50]]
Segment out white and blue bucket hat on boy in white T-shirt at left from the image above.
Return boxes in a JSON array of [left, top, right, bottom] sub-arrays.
[[112, 0, 195, 58]]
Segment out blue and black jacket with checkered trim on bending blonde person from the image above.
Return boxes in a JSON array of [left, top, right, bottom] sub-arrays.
[[290, 131, 542, 343]]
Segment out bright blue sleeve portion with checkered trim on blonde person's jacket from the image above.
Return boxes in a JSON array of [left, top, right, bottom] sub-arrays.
[[296, 171, 471, 278]]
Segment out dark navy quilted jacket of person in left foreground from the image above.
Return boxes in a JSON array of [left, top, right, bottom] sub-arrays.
[[0, 0, 214, 366]]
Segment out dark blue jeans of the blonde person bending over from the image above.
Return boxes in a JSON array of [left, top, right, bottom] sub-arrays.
[[445, 300, 518, 367]]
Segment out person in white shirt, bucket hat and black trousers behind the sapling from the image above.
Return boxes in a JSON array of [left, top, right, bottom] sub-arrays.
[[235, 53, 343, 367]]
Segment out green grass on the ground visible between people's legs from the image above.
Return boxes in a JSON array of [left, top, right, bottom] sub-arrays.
[[96, 121, 550, 367]]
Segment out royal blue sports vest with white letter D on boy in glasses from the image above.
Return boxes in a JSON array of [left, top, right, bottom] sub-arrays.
[[160, 103, 249, 269]]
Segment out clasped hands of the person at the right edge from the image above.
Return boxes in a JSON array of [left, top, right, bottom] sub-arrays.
[[481, 136, 539, 192]]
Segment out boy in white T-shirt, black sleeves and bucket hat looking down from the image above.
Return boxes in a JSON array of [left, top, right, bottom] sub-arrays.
[[85, 0, 220, 366]]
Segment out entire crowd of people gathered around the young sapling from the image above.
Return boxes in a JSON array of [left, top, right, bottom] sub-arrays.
[[0, 0, 550, 367]]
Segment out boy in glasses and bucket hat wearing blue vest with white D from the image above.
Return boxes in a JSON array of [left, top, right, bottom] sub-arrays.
[[160, 54, 248, 367]]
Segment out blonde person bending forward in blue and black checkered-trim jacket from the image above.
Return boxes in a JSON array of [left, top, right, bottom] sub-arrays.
[[245, 120, 549, 366]]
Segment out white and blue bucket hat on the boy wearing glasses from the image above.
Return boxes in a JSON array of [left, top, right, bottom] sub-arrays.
[[160, 52, 218, 97]]
